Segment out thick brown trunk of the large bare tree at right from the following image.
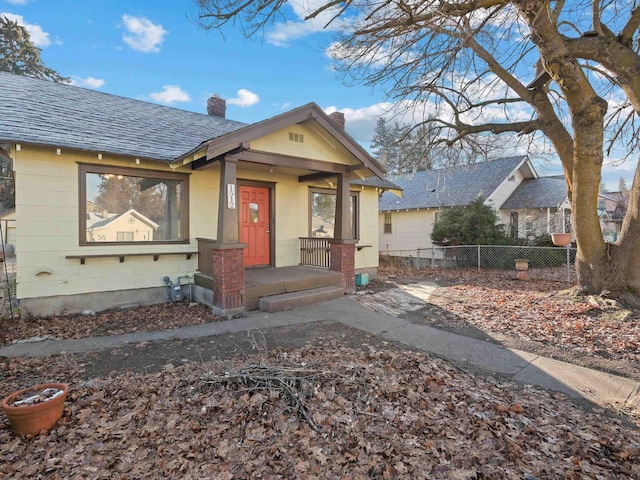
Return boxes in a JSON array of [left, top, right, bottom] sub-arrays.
[[515, 0, 640, 306]]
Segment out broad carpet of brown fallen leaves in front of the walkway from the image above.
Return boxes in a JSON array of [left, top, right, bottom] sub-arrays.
[[0, 341, 640, 479]]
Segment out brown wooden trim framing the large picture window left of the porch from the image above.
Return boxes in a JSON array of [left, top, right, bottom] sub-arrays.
[[78, 163, 190, 247]]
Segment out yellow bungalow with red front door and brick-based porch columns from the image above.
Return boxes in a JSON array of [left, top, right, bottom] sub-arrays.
[[0, 73, 395, 316]]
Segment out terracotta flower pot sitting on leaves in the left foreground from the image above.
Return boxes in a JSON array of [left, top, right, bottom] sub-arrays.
[[2, 383, 69, 435]]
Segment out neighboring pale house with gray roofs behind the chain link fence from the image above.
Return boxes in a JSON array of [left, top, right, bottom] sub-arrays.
[[379, 156, 571, 256]]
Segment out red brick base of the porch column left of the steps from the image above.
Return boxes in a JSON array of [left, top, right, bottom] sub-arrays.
[[213, 244, 245, 316]]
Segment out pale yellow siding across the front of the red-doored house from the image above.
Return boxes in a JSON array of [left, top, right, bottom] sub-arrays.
[[13, 141, 378, 299]]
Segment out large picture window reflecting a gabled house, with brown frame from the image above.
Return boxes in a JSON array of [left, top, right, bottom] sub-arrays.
[[79, 164, 189, 245]]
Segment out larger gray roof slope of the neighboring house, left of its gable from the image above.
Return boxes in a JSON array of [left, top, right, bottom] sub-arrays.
[[380, 156, 527, 211]]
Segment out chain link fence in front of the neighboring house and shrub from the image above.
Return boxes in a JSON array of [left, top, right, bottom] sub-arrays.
[[380, 245, 577, 283]]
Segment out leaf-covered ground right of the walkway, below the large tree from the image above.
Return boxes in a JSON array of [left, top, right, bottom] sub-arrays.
[[386, 269, 640, 374]]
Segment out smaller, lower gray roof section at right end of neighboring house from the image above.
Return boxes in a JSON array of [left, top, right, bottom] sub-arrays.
[[500, 175, 567, 209]]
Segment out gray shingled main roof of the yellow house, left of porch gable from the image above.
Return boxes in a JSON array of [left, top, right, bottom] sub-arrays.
[[0, 72, 246, 161]]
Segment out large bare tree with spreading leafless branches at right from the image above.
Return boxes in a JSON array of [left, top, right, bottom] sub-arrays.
[[198, 0, 640, 306]]
